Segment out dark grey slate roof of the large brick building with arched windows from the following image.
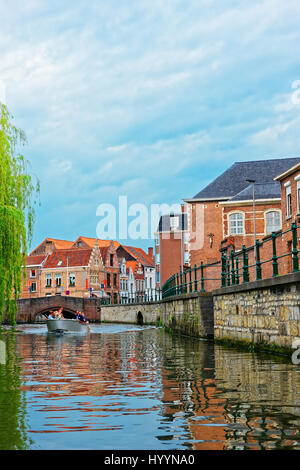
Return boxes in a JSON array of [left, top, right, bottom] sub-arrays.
[[193, 157, 300, 200]]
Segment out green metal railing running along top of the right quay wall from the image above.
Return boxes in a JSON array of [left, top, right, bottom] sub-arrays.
[[162, 223, 300, 298]]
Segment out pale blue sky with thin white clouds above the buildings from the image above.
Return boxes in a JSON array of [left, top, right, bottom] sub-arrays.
[[0, 0, 300, 253]]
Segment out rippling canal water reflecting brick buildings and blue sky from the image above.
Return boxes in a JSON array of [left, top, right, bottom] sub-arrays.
[[0, 324, 300, 451]]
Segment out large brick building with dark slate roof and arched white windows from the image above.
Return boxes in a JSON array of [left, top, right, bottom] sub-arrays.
[[185, 158, 299, 272]]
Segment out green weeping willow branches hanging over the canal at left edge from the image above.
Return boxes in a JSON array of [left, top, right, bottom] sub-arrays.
[[0, 103, 39, 324]]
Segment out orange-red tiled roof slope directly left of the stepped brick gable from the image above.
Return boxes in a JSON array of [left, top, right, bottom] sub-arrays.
[[44, 249, 92, 269]]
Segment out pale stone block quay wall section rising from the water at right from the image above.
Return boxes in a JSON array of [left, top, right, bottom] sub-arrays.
[[213, 272, 300, 349]]
